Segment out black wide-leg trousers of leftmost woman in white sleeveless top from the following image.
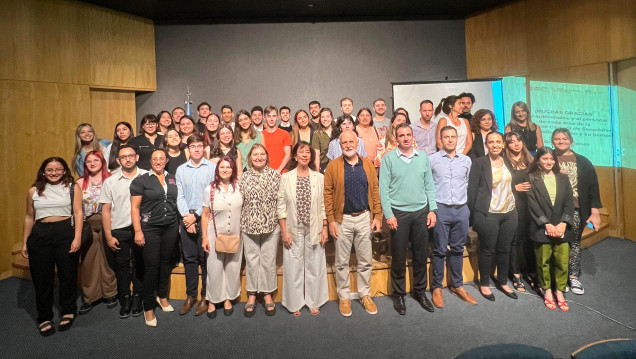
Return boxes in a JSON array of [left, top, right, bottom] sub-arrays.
[[27, 219, 79, 323]]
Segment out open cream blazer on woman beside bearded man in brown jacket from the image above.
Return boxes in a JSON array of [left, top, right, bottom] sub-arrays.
[[276, 168, 327, 245]]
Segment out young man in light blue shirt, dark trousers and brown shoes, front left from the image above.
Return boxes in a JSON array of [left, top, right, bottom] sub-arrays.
[[175, 134, 216, 315]]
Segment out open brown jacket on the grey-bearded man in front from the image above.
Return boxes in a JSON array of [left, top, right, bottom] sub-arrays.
[[324, 155, 382, 223]]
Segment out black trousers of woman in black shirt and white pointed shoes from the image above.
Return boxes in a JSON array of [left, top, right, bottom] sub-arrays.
[[141, 221, 179, 310]]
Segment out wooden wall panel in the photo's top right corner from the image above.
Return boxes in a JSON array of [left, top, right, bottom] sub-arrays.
[[607, 0, 636, 62]]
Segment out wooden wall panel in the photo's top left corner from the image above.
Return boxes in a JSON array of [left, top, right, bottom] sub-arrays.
[[0, 0, 90, 84]]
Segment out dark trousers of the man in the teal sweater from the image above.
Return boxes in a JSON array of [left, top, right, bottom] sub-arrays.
[[391, 206, 429, 296]]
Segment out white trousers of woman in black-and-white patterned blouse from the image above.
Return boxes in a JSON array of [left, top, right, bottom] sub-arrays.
[[242, 227, 280, 293]]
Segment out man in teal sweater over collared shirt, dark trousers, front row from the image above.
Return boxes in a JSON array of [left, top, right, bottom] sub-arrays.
[[380, 124, 437, 315]]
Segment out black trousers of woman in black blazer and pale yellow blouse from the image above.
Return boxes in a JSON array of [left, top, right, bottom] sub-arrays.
[[473, 210, 517, 286]]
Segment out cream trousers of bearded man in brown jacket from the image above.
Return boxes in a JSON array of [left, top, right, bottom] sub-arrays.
[[335, 211, 373, 299]]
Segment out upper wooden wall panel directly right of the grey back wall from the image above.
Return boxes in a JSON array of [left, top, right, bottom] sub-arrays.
[[465, 1, 528, 78]]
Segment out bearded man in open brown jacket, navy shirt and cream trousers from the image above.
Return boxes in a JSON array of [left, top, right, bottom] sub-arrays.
[[324, 131, 382, 317]]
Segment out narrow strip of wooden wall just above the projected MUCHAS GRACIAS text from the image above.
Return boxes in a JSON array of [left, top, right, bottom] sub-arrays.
[[527, 62, 609, 85]]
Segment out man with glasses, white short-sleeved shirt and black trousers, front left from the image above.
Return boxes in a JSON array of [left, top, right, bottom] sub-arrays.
[[99, 145, 148, 319]]
